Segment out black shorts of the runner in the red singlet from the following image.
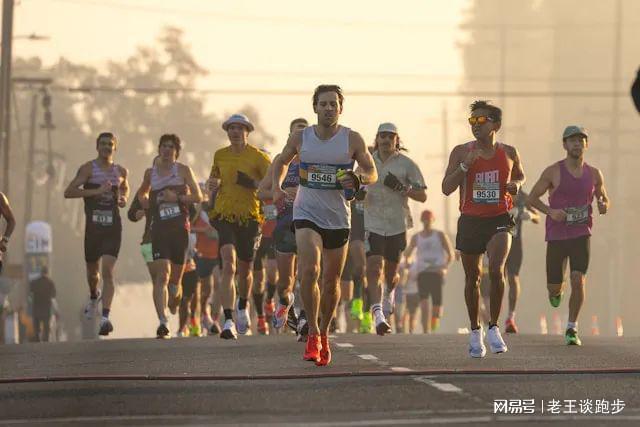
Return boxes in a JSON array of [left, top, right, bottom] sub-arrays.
[[456, 214, 515, 255]]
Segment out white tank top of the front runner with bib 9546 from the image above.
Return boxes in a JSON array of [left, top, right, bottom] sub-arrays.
[[293, 126, 353, 230]]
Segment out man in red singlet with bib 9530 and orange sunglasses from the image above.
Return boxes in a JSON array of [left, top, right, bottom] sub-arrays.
[[442, 101, 525, 357]]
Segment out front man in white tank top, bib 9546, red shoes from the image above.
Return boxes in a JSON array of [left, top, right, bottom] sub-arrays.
[[272, 85, 377, 366]]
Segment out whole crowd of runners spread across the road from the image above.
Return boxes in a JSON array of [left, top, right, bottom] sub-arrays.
[[0, 85, 609, 366]]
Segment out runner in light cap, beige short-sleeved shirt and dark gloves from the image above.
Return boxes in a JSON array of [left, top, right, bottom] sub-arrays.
[[364, 123, 427, 335]]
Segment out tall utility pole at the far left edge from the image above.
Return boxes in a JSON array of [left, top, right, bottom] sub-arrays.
[[0, 0, 14, 195]]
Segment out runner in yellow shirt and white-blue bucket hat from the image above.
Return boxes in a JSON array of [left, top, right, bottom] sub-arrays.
[[209, 114, 271, 339]]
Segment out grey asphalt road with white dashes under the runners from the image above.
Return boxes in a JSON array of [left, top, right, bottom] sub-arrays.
[[0, 335, 640, 426]]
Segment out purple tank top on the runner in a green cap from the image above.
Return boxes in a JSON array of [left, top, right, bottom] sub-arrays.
[[545, 160, 595, 242]]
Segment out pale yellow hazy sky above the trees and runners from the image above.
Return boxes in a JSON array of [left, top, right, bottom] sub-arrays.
[[14, 0, 467, 224]]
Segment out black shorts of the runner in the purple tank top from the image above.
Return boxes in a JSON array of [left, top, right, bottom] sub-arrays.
[[547, 236, 591, 285]]
